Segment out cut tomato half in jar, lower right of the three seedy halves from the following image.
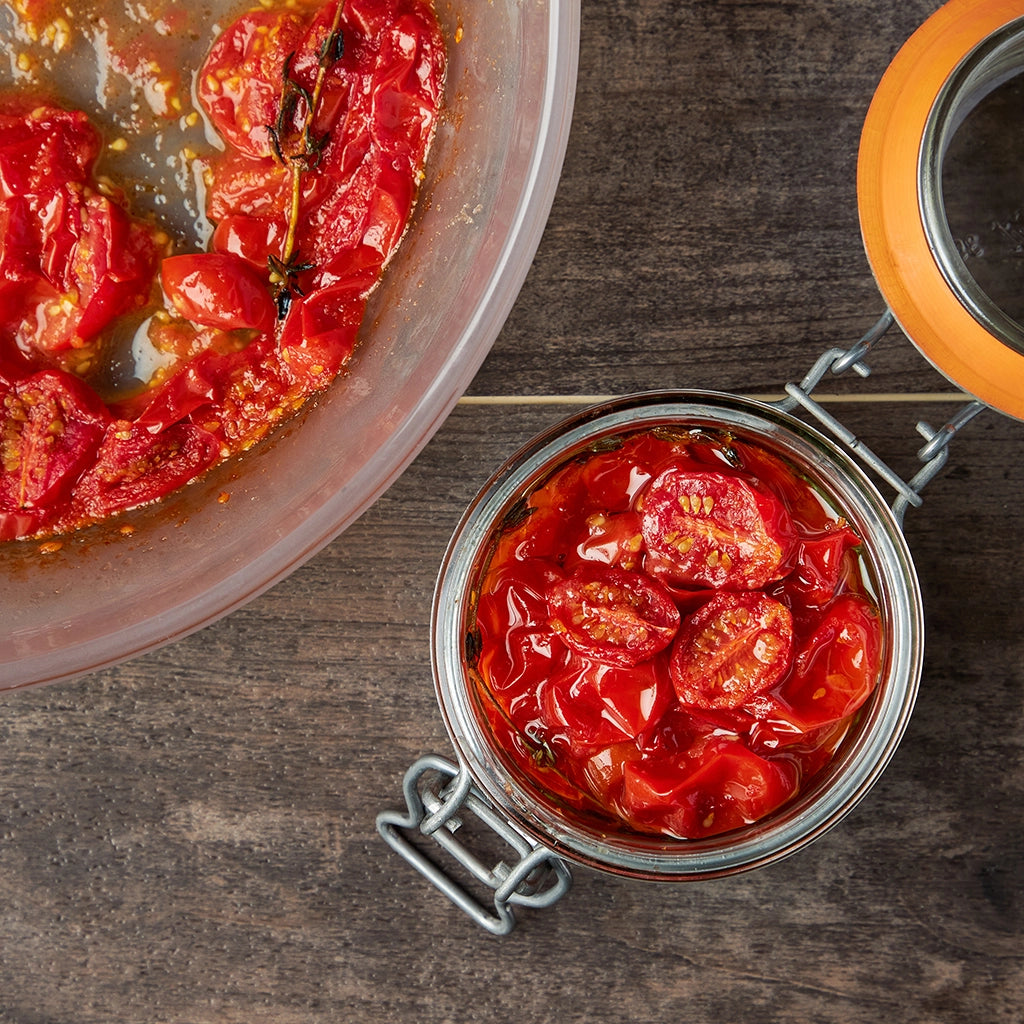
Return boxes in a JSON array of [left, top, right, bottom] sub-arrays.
[[671, 593, 793, 710]]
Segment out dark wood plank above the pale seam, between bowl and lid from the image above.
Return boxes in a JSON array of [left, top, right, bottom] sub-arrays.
[[473, 0, 954, 394]]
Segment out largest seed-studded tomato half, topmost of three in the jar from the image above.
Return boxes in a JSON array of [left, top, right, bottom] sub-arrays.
[[641, 466, 794, 590]]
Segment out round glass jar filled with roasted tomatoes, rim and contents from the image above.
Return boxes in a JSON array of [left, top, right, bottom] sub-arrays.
[[434, 392, 922, 878]]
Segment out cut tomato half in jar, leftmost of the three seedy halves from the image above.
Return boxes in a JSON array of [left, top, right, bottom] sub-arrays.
[[548, 562, 679, 666]]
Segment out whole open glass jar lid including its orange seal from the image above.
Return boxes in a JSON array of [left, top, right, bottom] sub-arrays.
[[857, 0, 1024, 419]]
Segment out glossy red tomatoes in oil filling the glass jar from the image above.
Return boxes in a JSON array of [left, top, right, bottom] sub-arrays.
[[466, 429, 883, 839]]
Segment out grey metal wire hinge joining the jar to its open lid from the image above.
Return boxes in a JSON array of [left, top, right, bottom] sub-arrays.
[[773, 309, 988, 526]]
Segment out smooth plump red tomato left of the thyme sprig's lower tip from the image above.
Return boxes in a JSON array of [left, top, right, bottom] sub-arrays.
[[160, 252, 278, 334]]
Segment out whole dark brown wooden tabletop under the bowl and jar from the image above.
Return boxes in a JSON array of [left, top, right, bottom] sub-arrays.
[[0, 0, 1024, 1024]]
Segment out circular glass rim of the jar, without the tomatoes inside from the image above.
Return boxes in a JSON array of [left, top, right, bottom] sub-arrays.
[[432, 391, 923, 879]]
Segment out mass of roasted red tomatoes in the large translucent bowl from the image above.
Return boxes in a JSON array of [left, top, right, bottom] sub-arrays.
[[0, 0, 445, 541]]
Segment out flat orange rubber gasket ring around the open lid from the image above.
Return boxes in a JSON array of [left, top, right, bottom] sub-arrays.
[[857, 0, 1024, 419]]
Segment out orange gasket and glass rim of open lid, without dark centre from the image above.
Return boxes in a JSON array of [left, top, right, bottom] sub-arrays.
[[857, 0, 1024, 419]]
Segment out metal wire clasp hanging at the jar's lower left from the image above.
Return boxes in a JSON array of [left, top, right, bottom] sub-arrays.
[[377, 755, 572, 935]]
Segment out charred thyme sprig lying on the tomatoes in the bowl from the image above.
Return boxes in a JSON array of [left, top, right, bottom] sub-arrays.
[[266, 3, 344, 321]]
